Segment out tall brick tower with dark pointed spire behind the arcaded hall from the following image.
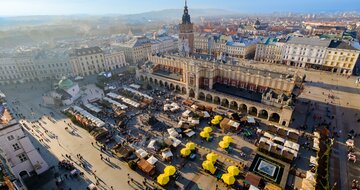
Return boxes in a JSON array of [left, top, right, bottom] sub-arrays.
[[179, 0, 194, 56]]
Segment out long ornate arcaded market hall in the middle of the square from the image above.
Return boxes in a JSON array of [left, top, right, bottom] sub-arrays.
[[137, 54, 302, 126]]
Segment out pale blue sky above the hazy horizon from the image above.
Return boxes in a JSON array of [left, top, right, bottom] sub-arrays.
[[0, 0, 360, 16]]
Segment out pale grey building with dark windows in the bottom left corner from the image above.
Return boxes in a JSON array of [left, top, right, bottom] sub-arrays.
[[0, 100, 49, 186]]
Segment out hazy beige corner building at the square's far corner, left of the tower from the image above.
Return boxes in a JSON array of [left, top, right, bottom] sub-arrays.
[[118, 37, 151, 64]]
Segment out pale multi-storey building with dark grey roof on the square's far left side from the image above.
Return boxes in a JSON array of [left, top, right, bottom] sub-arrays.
[[70, 46, 106, 76]]
